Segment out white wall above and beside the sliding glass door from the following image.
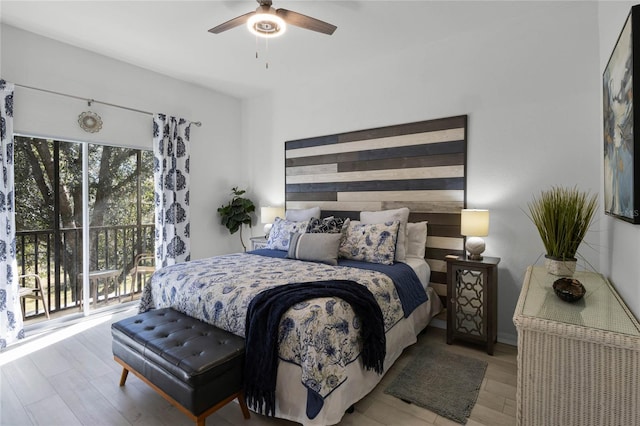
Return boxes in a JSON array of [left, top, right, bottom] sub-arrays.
[[0, 25, 247, 259]]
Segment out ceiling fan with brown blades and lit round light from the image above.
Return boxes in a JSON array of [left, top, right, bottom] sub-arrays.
[[209, 0, 338, 37]]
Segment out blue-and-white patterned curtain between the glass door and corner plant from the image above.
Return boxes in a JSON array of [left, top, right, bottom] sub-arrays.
[[153, 114, 191, 268]]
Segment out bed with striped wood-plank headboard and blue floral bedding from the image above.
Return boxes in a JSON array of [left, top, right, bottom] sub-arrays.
[[141, 116, 467, 425]]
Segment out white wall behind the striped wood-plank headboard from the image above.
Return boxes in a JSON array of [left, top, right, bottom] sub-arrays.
[[243, 2, 602, 343]]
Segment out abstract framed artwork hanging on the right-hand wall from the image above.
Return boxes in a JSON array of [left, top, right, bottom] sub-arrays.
[[602, 6, 640, 224]]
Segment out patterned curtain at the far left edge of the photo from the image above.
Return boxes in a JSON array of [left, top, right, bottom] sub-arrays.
[[0, 80, 24, 348]]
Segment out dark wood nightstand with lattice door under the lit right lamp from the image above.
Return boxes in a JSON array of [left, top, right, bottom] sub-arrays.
[[447, 256, 500, 355]]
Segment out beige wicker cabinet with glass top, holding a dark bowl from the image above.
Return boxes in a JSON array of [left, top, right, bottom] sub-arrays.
[[513, 267, 640, 426]]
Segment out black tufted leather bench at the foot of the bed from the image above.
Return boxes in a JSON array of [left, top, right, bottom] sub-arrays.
[[111, 308, 249, 426]]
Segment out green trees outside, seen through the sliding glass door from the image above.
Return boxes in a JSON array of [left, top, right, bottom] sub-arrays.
[[14, 136, 154, 282]]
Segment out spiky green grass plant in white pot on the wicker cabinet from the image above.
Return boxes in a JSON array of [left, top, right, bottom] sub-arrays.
[[528, 186, 598, 276]]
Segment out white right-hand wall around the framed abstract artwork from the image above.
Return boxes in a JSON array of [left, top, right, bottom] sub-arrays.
[[598, 2, 640, 318]]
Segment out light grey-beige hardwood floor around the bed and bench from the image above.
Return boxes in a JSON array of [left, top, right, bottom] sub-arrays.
[[0, 310, 516, 426]]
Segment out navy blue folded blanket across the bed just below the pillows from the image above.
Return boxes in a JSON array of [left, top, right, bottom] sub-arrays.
[[249, 249, 428, 318]]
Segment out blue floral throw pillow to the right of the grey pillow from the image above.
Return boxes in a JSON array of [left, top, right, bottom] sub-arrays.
[[338, 220, 400, 265]]
